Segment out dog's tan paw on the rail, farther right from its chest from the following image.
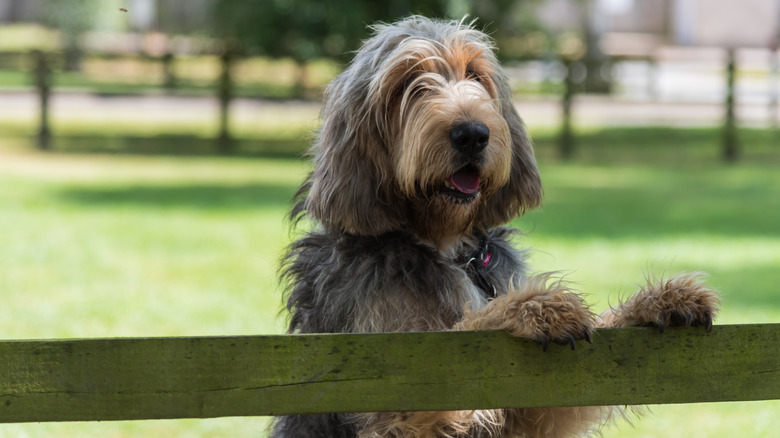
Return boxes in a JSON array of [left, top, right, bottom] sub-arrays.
[[611, 272, 720, 333]]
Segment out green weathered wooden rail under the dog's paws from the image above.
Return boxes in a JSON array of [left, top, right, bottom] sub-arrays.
[[0, 324, 780, 422]]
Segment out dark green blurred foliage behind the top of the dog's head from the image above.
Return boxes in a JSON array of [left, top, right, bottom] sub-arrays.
[[207, 0, 546, 62]]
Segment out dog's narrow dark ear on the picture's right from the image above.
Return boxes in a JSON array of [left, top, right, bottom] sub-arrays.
[[479, 67, 542, 227]]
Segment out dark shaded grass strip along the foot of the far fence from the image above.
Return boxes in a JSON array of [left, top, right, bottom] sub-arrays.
[[10, 126, 780, 166]]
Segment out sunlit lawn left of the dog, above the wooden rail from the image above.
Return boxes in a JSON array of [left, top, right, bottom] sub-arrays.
[[0, 154, 304, 338]]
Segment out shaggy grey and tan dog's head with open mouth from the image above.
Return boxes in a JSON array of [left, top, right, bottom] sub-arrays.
[[295, 17, 541, 246]]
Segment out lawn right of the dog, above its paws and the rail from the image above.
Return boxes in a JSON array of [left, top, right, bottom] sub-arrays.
[[517, 164, 780, 323]]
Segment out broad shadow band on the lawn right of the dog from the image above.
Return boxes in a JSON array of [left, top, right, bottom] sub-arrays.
[[515, 171, 780, 239]]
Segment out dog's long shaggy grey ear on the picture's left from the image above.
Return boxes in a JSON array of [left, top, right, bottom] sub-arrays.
[[293, 64, 405, 235]]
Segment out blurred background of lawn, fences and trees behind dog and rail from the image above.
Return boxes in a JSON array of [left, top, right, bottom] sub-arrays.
[[0, 0, 780, 437]]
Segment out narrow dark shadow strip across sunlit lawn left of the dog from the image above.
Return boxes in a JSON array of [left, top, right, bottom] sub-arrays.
[[59, 184, 297, 211]]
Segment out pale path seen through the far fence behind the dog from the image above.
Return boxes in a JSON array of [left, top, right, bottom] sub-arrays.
[[0, 87, 780, 135]]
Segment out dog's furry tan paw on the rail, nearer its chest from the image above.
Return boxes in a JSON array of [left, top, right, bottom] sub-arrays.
[[456, 276, 595, 351]]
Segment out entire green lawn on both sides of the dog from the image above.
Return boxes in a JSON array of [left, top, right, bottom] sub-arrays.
[[0, 136, 780, 437]]
